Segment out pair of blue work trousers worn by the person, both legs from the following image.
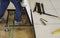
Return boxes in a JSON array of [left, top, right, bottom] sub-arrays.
[[0, 0, 22, 22]]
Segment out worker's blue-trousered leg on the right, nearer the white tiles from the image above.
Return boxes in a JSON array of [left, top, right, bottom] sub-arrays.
[[11, 0, 22, 22]]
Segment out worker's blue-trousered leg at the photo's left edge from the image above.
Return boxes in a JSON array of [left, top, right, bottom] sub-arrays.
[[0, 0, 10, 19]]
